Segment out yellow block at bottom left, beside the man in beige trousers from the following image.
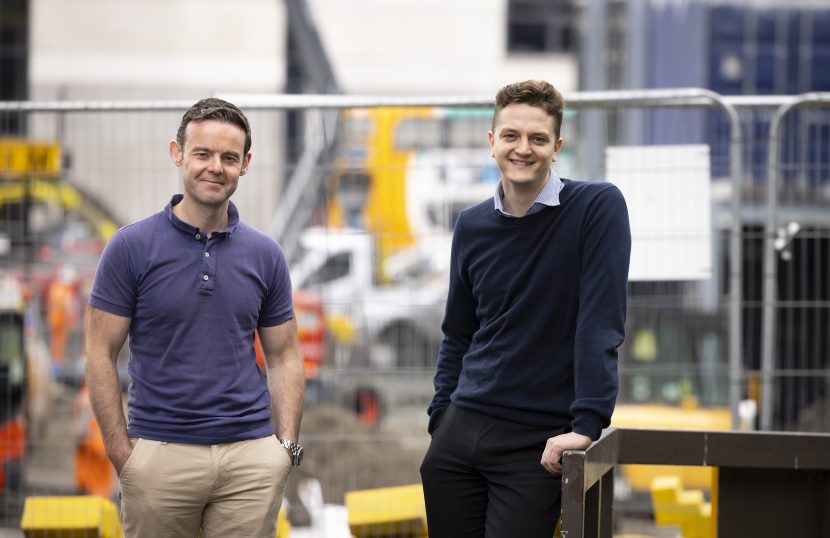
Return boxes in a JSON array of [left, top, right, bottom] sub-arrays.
[[20, 495, 124, 538]]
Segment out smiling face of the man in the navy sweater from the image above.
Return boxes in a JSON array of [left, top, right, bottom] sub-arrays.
[[487, 103, 562, 186]]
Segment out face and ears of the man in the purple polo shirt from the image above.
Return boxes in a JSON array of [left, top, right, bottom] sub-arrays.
[[170, 120, 251, 208]]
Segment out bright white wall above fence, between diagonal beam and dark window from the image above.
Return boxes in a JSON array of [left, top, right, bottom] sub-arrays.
[[308, 0, 577, 95]]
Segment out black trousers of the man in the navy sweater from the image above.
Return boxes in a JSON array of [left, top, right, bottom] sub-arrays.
[[421, 404, 562, 538]]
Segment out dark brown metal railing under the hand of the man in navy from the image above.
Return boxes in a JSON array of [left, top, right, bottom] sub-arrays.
[[561, 428, 830, 538]]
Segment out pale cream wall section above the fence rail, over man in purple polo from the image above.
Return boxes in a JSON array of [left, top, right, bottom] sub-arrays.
[[30, 0, 285, 98]]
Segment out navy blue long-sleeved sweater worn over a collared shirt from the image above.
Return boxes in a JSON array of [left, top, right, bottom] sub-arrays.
[[429, 179, 631, 439]]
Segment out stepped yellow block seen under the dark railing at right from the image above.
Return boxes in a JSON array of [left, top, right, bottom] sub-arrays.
[[651, 476, 712, 538]]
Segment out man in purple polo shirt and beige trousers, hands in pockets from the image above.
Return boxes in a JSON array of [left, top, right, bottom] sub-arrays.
[[86, 98, 305, 538]]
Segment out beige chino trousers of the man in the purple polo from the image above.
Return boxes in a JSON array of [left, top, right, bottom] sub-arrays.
[[119, 435, 291, 538]]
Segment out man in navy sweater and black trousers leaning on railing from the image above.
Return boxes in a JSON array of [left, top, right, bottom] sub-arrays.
[[421, 77, 631, 538]]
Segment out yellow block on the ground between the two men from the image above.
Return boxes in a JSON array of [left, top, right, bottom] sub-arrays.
[[345, 484, 428, 538]]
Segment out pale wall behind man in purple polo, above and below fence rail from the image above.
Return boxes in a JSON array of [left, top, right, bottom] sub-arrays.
[[29, 0, 286, 229]]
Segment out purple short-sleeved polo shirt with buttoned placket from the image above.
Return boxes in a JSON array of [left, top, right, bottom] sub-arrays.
[[89, 194, 294, 444]]
